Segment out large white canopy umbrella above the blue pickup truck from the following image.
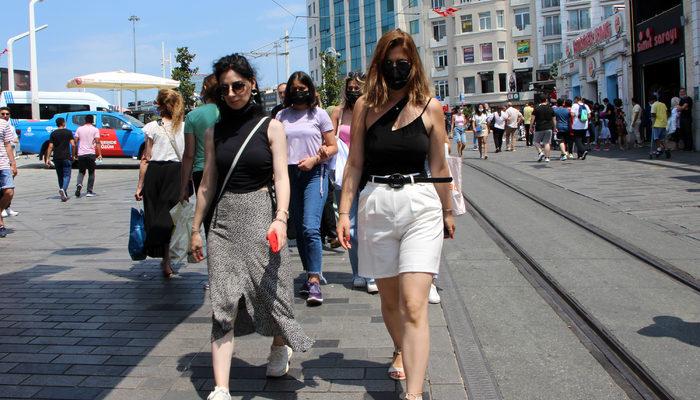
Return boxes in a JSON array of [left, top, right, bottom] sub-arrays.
[[66, 70, 180, 107]]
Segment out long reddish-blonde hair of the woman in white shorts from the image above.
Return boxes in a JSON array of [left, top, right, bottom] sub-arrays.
[[364, 29, 430, 109]]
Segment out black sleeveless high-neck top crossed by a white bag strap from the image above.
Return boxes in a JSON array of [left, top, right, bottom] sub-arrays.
[[214, 107, 272, 193]]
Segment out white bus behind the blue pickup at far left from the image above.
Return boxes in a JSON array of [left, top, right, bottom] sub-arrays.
[[0, 90, 111, 120]]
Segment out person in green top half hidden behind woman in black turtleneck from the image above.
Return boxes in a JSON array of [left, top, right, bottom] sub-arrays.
[[180, 74, 219, 200]]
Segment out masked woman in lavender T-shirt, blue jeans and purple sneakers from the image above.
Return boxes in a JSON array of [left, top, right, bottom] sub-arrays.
[[276, 71, 338, 305]]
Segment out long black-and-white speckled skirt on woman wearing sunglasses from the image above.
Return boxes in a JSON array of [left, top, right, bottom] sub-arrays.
[[207, 191, 314, 351]]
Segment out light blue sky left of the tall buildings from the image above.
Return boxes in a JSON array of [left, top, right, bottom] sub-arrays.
[[0, 0, 308, 105]]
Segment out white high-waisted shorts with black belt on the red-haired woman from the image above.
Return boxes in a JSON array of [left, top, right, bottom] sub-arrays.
[[357, 182, 444, 279]]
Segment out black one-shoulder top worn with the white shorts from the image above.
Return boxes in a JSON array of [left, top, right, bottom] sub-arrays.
[[363, 97, 430, 182]]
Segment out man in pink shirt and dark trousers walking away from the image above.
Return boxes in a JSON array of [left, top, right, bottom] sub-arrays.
[[73, 114, 102, 197]]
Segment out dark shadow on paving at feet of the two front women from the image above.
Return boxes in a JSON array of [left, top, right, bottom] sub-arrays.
[[177, 352, 403, 400]]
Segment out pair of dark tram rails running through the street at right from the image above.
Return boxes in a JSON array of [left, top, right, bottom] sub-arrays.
[[462, 161, 700, 400]]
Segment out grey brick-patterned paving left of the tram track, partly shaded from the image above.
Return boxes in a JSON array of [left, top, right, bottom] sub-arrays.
[[0, 160, 466, 400]]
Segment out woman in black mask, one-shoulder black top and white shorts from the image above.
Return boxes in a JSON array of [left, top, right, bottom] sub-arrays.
[[338, 29, 455, 400]]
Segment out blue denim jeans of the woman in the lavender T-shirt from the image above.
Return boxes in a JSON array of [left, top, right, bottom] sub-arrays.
[[288, 164, 328, 277]]
